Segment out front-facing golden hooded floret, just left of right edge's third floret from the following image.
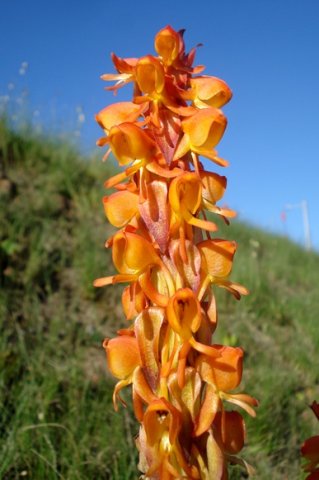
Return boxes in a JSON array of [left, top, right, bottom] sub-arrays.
[[169, 172, 217, 232]]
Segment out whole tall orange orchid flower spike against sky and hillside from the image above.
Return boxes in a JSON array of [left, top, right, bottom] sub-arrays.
[[95, 26, 257, 480]]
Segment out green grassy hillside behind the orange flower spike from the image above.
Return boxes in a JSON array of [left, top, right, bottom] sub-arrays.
[[0, 119, 319, 480]]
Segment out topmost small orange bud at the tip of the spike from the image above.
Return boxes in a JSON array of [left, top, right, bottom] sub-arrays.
[[155, 25, 183, 66]]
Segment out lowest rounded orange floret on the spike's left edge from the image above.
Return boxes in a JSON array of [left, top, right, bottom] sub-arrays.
[[103, 335, 141, 410]]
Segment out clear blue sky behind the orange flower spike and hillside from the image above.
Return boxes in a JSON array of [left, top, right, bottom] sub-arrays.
[[0, 0, 319, 248]]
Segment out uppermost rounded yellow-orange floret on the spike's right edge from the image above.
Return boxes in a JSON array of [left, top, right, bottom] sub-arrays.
[[190, 76, 232, 108]]
